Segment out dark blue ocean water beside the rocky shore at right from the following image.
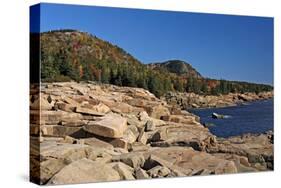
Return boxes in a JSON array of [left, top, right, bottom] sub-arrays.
[[188, 99, 274, 138]]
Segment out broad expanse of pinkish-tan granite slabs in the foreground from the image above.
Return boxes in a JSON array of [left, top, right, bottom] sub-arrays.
[[30, 82, 273, 185]]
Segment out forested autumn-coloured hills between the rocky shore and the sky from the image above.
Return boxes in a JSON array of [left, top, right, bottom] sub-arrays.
[[31, 30, 273, 97]]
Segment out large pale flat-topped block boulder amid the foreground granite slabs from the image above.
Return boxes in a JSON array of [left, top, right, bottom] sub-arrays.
[[84, 114, 127, 138]]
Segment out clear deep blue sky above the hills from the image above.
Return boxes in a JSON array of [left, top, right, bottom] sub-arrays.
[[30, 4, 273, 85]]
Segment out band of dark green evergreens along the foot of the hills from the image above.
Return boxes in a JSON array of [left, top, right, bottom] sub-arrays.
[[41, 49, 272, 97]]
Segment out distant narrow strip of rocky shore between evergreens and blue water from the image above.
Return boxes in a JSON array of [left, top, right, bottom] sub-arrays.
[[164, 91, 273, 109]]
